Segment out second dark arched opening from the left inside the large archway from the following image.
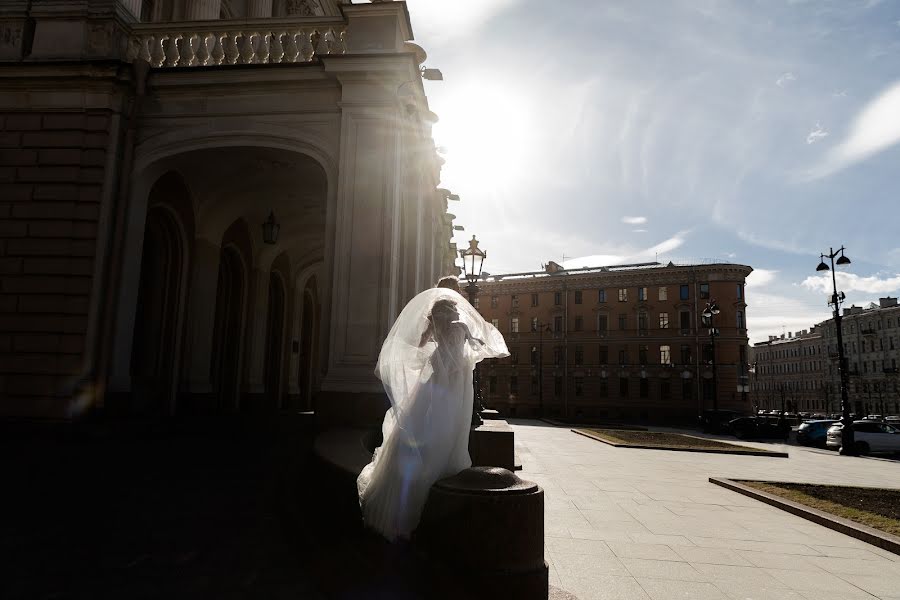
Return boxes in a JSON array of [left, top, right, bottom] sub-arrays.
[[210, 246, 247, 411]]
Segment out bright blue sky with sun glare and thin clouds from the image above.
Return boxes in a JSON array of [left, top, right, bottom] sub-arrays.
[[408, 0, 900, 342]]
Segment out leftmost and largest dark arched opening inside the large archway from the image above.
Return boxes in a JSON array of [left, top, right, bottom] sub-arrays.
[[131, 204, 186, 415]]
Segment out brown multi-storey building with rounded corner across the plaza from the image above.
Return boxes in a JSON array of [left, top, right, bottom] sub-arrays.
[[477, 263, 752, 423]]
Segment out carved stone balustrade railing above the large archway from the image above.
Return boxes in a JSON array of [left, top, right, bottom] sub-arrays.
[[127, 17, 347, 67]]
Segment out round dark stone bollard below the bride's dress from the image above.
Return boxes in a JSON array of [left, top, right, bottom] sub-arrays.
[[413, 467, 548, 600]]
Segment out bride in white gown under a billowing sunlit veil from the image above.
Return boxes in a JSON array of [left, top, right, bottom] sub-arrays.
[[356, 288, 509, 541]]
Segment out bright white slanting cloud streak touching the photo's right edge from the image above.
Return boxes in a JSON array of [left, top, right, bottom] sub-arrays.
[[803, 82, 900, 180]]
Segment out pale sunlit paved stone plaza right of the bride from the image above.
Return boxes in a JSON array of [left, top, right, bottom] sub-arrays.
[[511, 421, 900, 600]]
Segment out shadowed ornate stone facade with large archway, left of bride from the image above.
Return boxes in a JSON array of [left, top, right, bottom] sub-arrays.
[[0, 0, 455, 421]]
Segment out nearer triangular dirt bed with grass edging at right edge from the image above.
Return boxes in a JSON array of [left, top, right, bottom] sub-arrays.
[[740, 481, 900, 536]]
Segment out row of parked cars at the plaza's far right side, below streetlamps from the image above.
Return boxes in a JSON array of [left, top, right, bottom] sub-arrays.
[[700, 410, 900, 455]]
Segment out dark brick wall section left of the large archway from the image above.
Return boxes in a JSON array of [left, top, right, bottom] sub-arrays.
[[0, 111, 111, 417]]
